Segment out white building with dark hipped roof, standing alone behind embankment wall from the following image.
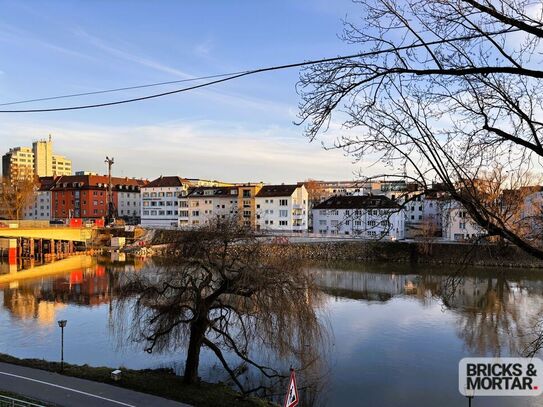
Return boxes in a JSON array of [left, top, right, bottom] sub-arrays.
[[313, 195, 405, 240]]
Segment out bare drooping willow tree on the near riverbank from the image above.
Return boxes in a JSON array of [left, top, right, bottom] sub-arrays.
[[120, 219, 321, 393]]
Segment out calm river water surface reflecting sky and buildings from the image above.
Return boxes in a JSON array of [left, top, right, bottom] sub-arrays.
[[0, 257, 543, 407]]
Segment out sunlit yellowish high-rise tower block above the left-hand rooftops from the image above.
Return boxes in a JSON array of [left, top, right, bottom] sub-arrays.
[[2, 136, 72, 179]]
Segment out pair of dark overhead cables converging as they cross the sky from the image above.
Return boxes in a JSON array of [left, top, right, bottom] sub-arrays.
[[0, 28, 520, 113]]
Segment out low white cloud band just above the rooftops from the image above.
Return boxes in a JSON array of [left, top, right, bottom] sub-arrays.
[[0, 122, 380, 182]]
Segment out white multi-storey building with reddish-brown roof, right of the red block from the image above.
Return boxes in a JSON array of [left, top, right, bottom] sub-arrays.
[[140, 176, 189, 227]]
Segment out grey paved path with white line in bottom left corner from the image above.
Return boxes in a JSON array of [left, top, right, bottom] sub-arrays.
[[0, 363, 190, 407]]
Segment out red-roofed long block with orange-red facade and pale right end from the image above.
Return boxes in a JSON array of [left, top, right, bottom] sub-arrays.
[[51, 175, 145, 220]]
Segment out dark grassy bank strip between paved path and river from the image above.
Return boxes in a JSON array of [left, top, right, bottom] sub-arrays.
[[0, 354, 275, 407]]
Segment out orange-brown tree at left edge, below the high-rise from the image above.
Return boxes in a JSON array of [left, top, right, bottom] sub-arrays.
[[0, 177, 37, 220]]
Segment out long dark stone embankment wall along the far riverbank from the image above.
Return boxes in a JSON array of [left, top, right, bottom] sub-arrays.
[[262, 241, 543, 268]]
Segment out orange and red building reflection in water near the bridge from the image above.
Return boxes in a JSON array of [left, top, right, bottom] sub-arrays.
[[3, 265, 116, 324]]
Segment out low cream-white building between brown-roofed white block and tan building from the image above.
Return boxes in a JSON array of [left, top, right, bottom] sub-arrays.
[[179, 186, 239, 227]]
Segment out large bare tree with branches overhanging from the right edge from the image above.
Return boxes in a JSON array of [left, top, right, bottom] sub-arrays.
[[299, 0, 543, 259]]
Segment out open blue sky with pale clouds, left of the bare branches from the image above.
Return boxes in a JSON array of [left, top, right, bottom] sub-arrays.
[[0, 0, 376, 183]]
